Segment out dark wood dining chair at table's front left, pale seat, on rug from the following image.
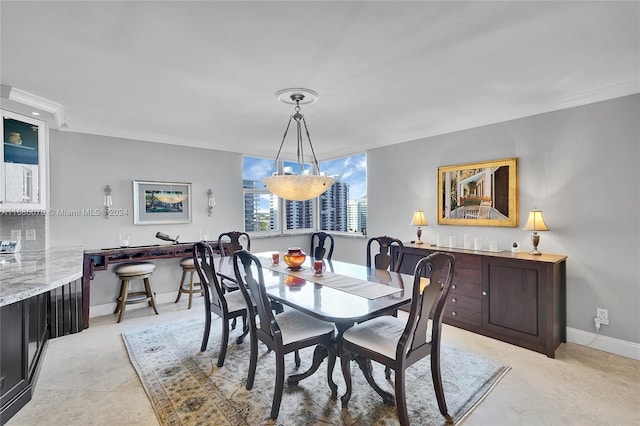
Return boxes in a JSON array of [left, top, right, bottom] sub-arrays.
[[233, 250, 338, 419]]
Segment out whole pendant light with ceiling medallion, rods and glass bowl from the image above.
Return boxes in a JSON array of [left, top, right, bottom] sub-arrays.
[[262, 89, 334, 201]]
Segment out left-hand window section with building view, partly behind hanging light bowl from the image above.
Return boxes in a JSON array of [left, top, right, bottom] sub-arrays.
[[242, 156, 315, 232]]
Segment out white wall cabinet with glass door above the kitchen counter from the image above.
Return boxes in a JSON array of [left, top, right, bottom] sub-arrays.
[[0, 110, 48, 211]]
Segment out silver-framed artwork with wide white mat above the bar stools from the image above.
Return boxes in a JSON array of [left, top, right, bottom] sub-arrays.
[[133, 180, 191, 225]]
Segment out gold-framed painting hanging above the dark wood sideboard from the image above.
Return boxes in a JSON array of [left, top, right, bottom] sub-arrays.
[[438, 158, 518, 227]]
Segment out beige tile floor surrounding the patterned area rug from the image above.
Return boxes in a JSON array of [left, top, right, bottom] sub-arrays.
[[7, 298, 640, 426]]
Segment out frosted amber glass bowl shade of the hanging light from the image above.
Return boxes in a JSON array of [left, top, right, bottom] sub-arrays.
[[262, 175, 334, 201]]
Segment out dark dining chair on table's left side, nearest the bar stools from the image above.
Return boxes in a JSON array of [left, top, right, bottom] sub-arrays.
[[193, 243, 249, 367]]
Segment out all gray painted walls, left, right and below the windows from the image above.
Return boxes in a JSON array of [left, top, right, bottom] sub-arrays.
[[50, 95, 640, 343]]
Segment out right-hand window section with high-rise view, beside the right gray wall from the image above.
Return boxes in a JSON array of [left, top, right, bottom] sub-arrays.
[[319, 153, 367, 235]]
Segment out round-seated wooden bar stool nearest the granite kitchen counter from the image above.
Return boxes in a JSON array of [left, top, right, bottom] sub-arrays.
[[114, 262, 158, 322]]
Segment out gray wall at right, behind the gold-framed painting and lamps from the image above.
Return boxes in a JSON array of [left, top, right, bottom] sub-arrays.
[[367, 95, 640, 343]]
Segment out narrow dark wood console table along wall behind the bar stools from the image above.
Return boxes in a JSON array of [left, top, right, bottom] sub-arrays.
[[82, 241, 224, 329]]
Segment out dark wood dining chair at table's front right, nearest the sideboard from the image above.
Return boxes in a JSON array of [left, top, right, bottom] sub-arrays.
[[340, 252, 455, 426]]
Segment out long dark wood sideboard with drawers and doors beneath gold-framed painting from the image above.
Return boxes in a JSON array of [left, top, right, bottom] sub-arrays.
[[392, 243, 567, 358]]
